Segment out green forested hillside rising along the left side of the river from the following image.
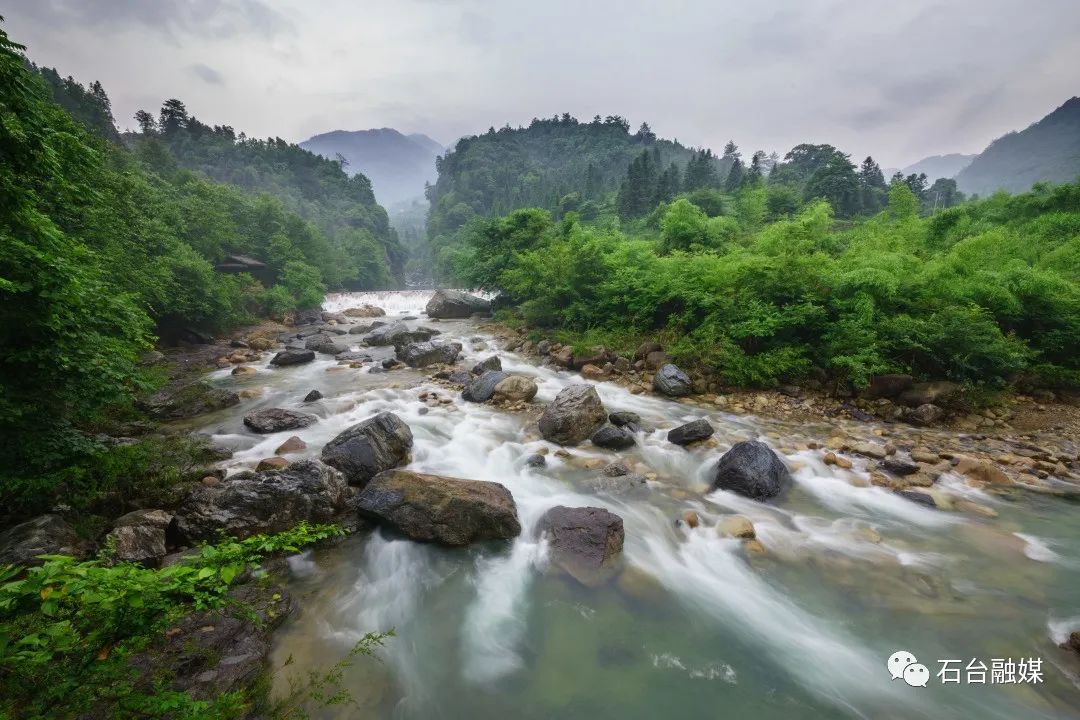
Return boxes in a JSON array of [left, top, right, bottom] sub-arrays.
[[0, 26, 395, 500]]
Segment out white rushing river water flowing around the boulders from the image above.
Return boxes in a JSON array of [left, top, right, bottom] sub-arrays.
[[192, 291, 1080, 720]]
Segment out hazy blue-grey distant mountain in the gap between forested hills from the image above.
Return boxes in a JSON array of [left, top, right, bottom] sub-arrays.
[[300, 127, 445, 205]]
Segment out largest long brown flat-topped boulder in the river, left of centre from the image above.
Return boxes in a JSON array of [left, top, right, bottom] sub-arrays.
[[356, 470, 522, 545]]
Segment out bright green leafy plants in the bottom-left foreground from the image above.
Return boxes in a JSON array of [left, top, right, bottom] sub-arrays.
[[0, 524, 343, 720]]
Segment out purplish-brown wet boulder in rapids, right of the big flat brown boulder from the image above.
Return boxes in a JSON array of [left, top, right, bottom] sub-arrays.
[[537, 505, 625, 587]]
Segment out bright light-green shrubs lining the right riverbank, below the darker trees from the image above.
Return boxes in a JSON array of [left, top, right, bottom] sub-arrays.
[[442, 184, 1080, 386]]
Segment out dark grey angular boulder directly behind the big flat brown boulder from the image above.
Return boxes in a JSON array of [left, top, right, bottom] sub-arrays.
[[322, 412, 413, 486]]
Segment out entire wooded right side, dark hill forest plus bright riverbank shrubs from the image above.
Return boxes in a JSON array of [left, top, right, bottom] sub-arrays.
[[429, 121, 1080, 389]]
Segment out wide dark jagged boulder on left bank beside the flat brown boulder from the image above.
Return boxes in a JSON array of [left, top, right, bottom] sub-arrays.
[[173, 460, 350, 544]]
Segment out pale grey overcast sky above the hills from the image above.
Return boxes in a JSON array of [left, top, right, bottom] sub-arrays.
[[8, 0, 1080, 166]]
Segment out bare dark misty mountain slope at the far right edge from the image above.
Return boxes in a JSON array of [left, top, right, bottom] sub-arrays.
[[956, 97, 1080, 195]]
